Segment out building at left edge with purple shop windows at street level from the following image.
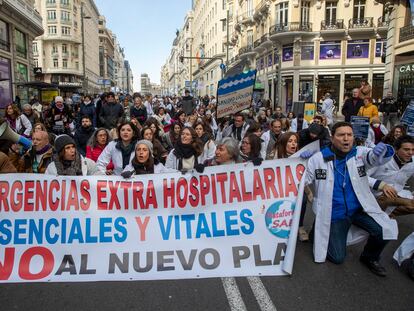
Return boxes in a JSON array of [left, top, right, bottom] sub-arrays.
[[0, 0, 43, 109]]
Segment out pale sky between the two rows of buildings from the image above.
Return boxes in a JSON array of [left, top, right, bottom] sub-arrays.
[[95, 0, 191, 91]]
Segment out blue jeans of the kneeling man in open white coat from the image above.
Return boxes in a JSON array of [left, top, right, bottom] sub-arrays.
[[327, 211, 388, 264]]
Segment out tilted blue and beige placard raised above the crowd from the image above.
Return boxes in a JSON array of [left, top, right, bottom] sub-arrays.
[[217, 70, 256, 118]]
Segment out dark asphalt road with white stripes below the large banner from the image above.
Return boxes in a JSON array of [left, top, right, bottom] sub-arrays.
[[0, 213, 414, 311]]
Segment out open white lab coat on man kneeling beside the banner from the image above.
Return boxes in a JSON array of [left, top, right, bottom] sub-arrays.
[[306, 147, 398, 262]]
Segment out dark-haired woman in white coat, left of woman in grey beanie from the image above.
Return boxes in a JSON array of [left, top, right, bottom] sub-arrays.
[[97, 121, 140, 175]]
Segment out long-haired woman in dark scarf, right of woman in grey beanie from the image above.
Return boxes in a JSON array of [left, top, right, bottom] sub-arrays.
[[165, 127, 204, 172]]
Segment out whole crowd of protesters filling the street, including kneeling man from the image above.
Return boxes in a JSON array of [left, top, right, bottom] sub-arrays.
[[0, 89, 414, 278]]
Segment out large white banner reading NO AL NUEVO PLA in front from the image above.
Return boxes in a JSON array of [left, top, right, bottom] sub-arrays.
[[0, 159, 305, 282]]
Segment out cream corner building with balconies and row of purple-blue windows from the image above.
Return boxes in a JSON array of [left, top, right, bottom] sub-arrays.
[[228, 0, 389, 109]]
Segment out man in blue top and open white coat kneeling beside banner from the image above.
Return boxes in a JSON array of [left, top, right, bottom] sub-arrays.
[[306, 122, 398, 276]]
